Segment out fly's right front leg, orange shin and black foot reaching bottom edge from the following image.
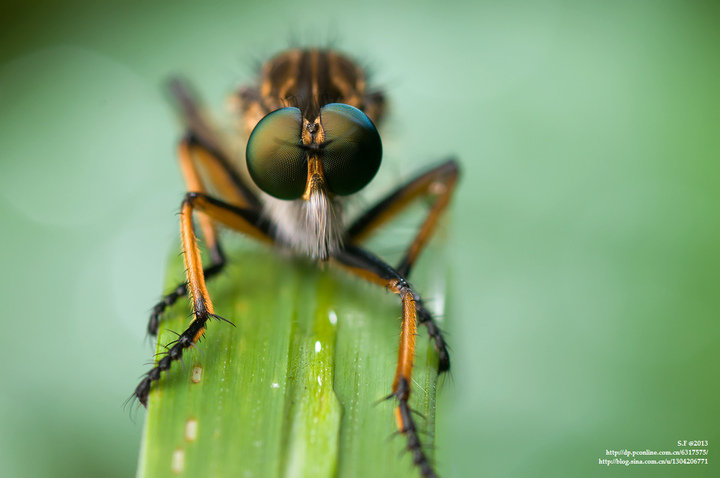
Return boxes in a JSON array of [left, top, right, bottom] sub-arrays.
[[334, 246, 437, 478]]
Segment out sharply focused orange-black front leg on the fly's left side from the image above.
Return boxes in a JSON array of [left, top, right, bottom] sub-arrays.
[[133, 192, 273, 406]]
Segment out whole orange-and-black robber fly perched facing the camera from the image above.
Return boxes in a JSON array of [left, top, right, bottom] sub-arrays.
[[133, 49, 459, 477]]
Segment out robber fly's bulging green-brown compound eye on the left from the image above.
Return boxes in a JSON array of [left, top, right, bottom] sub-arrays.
[[245, 108, 307, 199]]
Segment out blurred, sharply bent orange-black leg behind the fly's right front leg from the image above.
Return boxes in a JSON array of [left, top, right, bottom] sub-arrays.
[[345, 160, 459, 372]]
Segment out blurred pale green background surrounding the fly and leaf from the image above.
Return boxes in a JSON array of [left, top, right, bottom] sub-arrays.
[[0, 0, 720, 477]]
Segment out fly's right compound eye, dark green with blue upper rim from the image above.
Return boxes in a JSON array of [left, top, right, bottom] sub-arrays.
[[320, 103, 382, 196]]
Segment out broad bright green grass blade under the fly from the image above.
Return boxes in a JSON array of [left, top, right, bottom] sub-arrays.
[[138, 239, 446, 478]]
